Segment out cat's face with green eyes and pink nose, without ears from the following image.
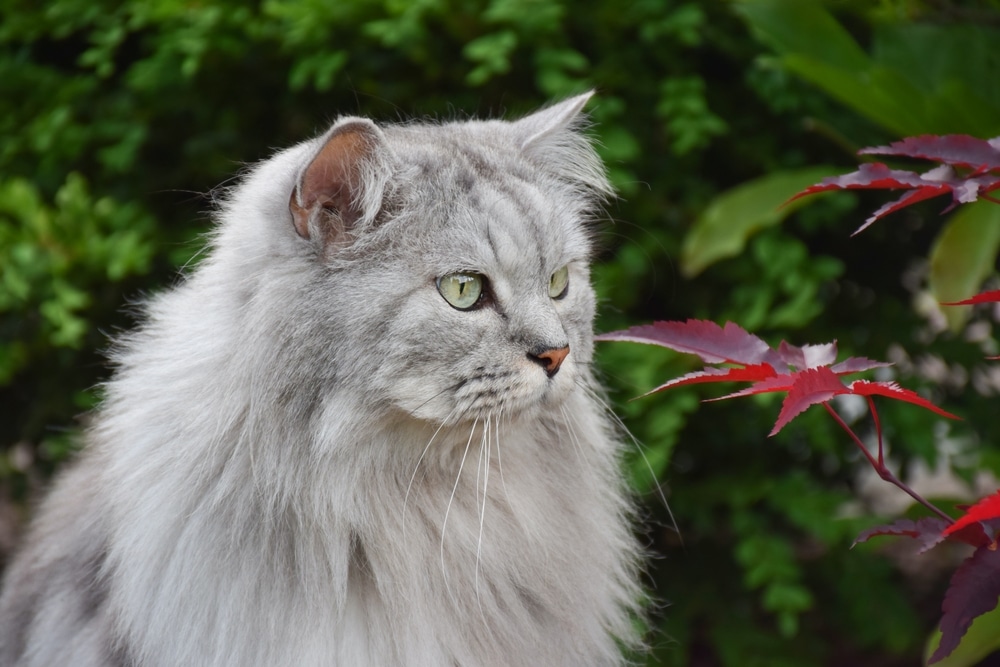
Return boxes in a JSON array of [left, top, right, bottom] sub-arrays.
[[376, 163, 594, 422]]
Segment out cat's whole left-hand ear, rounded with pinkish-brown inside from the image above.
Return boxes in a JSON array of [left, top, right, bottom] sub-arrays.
[[289, 118, 383, 249]]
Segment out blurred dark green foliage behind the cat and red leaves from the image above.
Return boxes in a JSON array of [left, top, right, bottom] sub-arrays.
[[0, 0, 1000, 667]]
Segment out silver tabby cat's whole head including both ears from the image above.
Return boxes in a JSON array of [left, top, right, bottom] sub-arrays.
[[246, 94, 610, 423]]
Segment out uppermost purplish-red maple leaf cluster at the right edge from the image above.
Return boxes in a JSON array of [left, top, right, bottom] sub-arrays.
[[789, 134, 1000, 234]]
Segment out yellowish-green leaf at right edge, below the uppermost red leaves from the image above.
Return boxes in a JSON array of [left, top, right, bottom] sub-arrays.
[[928, 201, 1000, 330]]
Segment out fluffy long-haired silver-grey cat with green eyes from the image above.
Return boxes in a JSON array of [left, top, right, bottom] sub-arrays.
[[0, 93, 641, 667]]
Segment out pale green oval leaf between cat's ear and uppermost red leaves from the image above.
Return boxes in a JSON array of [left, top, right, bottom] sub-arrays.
[[681, 166, 836, 278]]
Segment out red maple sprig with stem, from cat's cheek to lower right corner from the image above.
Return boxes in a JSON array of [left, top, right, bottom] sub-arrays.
[[597, 318, 980, 662]]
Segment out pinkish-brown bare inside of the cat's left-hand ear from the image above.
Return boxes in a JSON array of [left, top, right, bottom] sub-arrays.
[[289, 123, 375, 245]]
